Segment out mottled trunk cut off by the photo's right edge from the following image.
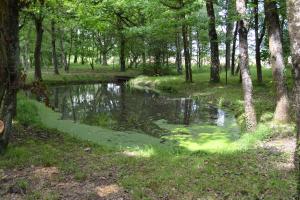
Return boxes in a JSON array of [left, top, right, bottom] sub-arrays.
[[288, 0, 300, 195]]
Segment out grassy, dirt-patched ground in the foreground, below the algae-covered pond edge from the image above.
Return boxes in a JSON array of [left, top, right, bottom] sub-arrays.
[[0, 126, 296, 200]]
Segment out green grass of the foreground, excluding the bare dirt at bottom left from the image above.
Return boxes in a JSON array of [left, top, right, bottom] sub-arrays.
[[0, 124, 296, 200]]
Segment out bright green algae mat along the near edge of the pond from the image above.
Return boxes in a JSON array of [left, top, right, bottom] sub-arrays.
[[19, 98, 270, 156]]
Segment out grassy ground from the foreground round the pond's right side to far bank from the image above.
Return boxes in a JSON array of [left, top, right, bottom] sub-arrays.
[[0, 65, 297, 200]]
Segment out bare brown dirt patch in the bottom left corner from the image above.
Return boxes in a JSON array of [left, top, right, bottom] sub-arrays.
[[0, 167, 131, 200]]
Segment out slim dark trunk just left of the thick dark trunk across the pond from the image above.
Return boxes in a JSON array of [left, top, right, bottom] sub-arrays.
[[182, 24, 193, 83]]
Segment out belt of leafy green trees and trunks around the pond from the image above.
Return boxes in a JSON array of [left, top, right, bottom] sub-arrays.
[[0, 0, 300, 169]]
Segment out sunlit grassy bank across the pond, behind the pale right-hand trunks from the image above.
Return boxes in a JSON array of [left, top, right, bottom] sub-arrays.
[[128, 69, 293, 128]]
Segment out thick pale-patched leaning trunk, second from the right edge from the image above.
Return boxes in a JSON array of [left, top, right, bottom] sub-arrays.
[[265, 0, 289, 123]]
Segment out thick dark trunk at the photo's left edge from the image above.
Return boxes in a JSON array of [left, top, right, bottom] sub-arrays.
[[0, 0, 19, 152]]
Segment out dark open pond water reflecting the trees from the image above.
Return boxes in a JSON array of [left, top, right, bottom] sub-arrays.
[[45, 83, 240, 139]]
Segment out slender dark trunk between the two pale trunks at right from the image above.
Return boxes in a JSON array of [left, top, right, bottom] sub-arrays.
[[254, 0, 263, 83]]
